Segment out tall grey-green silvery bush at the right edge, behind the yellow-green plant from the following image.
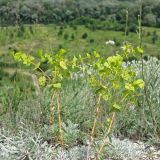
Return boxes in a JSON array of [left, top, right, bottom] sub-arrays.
[[116, 57, 160, 141]]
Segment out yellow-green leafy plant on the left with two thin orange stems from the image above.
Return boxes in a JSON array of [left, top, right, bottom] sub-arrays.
[[12, 49, 69, 146]]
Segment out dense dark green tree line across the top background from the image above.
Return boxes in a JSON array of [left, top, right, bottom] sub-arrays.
[[0, 0, 160, 31]]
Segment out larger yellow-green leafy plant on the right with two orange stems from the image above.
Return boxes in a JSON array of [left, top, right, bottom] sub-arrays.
[[80, 44, 144, 159]]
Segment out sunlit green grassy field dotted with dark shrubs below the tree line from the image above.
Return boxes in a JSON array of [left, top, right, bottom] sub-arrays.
[[0, 25, 160, 56]]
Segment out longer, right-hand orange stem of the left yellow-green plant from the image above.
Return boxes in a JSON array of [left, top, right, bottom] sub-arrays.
[[56, 93, 63, 147]]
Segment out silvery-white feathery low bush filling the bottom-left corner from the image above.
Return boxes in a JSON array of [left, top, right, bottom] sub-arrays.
[[0, 129, 55, 160]]
